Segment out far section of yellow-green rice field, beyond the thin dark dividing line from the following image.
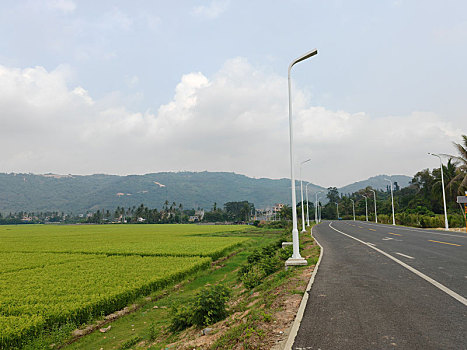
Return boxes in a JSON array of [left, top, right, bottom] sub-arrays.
[[0, 225, 249, 259]]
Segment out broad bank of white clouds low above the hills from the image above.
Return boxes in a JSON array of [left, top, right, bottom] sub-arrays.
[[0, 58, 466, 186]]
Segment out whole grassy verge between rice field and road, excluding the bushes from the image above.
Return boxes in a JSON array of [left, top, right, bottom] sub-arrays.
[[26, 228, 319, 350]]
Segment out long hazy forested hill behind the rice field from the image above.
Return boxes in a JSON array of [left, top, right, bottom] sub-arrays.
[[0, 172, 410, 214]]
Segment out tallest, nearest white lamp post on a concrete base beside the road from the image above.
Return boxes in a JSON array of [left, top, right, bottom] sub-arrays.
[[285, 49, 318, 266]]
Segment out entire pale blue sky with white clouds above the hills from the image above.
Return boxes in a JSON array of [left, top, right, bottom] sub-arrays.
[[0, 0, 467, 187]]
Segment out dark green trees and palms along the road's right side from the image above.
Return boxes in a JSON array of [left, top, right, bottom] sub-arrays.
[[322, 135, 467, 227]]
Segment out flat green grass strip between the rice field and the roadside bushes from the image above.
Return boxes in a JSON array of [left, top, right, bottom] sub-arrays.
[[62, 228, 283, 349]]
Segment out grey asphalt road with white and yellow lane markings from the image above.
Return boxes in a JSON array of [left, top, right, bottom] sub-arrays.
[[292, 221, 467, 350]]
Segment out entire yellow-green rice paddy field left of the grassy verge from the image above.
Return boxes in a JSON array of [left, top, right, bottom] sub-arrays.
[[0, 225, 248, 348]]
